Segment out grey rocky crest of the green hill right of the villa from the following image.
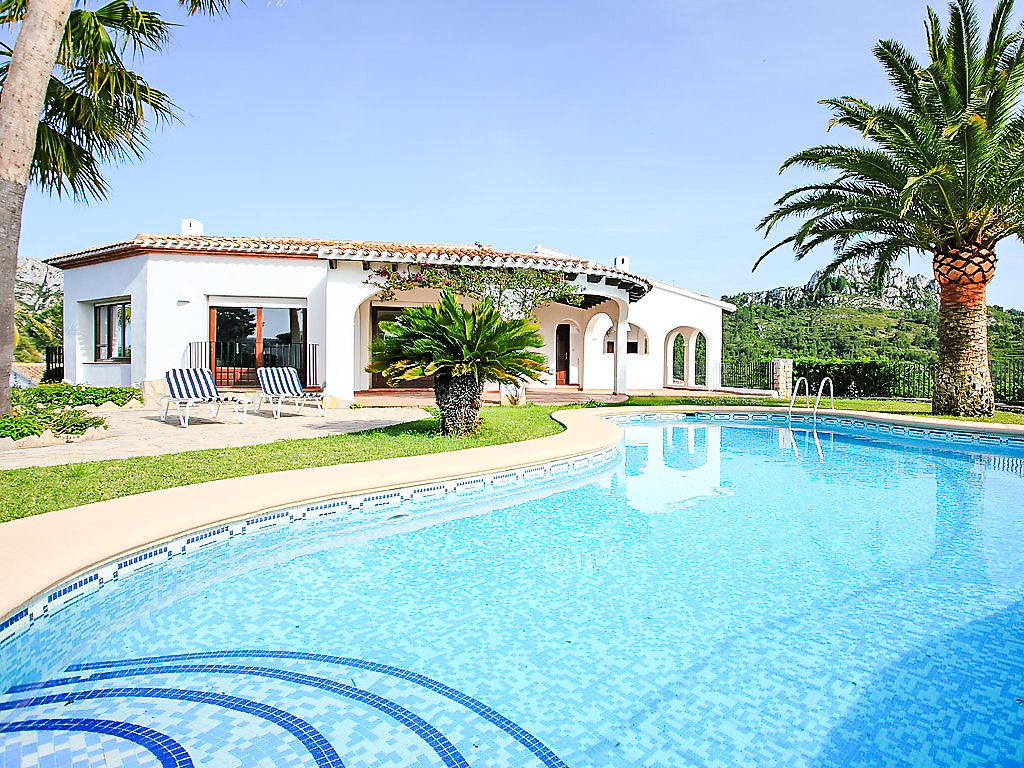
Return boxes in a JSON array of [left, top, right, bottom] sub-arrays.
[[725, 264, 939, 309]]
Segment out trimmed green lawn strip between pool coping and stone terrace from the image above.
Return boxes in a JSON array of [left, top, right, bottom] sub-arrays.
[[0, 397, 1024, 522]]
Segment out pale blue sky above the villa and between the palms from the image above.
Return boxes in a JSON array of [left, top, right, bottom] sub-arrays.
[[22, 0, 1024, 307]]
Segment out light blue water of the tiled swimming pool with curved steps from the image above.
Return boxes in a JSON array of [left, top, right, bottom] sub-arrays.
[[0, 420, 1024, 768]]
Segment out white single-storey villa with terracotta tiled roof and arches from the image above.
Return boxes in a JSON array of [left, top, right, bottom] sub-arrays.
[[48, 224, 735, 400]]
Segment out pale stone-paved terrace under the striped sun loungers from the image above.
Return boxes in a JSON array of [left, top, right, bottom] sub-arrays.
[[0, 406, 429, 470]]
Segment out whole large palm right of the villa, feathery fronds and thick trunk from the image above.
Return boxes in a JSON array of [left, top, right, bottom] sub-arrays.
[[755, 0, 1024, 416]]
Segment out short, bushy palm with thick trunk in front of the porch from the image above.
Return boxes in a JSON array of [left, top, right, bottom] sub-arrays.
[[367, 291, 547, 436]]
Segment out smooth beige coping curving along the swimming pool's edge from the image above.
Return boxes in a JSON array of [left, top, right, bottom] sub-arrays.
[[0, 404, 1024, 622]]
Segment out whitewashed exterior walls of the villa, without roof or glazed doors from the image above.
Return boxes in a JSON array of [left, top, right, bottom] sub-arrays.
[[58, 252, 725, 400]]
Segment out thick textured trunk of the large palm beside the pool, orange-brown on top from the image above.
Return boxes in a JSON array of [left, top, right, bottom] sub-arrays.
[[932, 246, 995, 416]]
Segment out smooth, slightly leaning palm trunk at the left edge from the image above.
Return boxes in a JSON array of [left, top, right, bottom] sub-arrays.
[[0, 0, 73, 416]]
